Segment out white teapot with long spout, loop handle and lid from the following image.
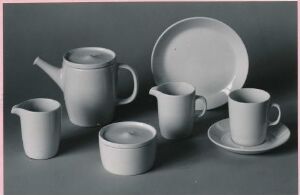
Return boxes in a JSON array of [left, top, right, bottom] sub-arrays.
[[33, 47, 138, 127]]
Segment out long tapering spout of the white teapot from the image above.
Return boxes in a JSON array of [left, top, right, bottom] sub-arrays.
[[33, 57, 63, 90]]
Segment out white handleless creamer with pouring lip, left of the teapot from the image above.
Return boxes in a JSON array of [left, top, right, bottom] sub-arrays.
[[11, 98, 61, 159]]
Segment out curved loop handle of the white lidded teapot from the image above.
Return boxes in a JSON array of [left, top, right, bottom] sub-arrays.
[[118, 64, 139, 105]]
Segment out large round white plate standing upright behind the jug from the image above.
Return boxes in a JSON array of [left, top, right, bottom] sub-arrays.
[[151, 17, 249, 109]]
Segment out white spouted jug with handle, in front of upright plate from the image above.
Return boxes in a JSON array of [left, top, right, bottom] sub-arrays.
[[149, 82, 207, 139]]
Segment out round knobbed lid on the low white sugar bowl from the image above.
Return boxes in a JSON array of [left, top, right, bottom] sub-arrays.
[[99, 121, 156, 149]]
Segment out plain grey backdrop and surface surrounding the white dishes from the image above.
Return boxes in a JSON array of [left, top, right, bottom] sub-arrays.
[[4, 2, 297, 195]]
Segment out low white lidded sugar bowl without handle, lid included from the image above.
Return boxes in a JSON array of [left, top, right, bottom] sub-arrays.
[[99, 121, 156, 175]]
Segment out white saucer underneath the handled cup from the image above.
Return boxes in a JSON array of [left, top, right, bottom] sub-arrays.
[[207, 118, 291, 154]]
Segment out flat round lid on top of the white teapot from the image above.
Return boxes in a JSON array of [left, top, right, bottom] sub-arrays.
[[64, 47, 116, 69]]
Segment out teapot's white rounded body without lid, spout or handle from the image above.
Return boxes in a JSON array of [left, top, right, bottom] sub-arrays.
[[61, 61, 117, 126]]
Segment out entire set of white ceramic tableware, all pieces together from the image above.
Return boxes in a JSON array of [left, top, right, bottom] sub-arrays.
[[11, 17, 290, 175]]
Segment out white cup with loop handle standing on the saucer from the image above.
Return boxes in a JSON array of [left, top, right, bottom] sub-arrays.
[[228, 88, 281, 146]]
